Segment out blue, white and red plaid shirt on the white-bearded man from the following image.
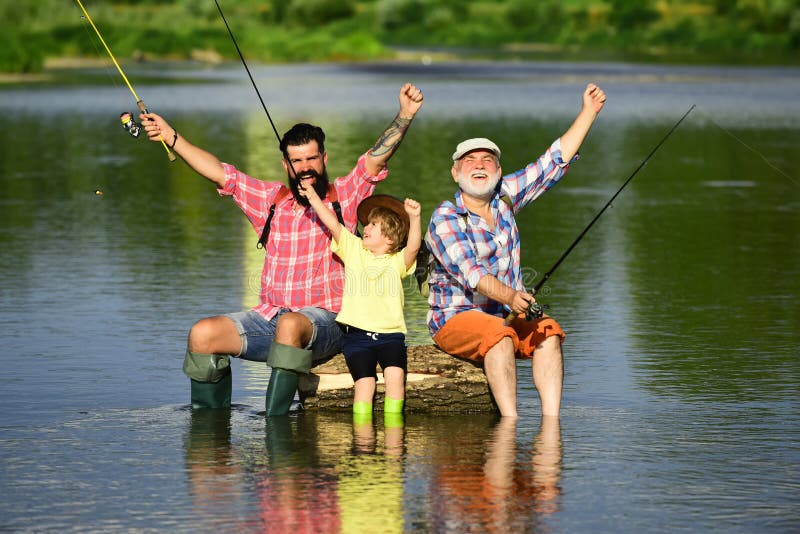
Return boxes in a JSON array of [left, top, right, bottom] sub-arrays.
[[425, 138, 578, 335]]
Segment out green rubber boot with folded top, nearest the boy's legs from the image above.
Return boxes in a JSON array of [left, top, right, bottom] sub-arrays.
[[265, 342, 311, 416]]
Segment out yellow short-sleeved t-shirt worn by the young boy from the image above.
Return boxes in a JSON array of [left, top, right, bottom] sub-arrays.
[[331, 228, 416, 334]]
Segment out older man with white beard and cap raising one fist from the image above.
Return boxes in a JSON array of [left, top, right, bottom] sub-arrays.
[[425, 83, 606, 417]]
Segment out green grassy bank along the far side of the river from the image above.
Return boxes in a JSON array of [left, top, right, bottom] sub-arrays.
[[0, 0, 800, 72]]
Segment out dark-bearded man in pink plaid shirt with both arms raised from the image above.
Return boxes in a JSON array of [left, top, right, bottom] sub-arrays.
[[141, 83, 423, 415]]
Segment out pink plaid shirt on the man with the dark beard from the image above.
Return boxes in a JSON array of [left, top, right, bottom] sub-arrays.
[[217, 154, 388, 320]]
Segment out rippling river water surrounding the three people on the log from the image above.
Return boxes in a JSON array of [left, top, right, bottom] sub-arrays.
[[0, 62, 800, 532]]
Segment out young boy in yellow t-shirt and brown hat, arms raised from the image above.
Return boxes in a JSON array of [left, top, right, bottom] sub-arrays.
[[300, 181, 422, 415]]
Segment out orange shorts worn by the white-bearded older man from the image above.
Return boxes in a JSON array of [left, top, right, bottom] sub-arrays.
[[433, 310, 566, 362]]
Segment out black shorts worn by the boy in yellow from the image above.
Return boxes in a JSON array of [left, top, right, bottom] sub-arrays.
[[342, 325, 408, 381]]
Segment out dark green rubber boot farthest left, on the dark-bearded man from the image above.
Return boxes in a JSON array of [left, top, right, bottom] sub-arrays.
[[183, 350, 233, 408]]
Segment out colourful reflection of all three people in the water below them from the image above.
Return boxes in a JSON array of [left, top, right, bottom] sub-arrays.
[[184, 410, 563, 532]]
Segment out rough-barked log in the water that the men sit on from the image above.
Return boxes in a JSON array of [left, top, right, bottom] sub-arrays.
[[298, 345, 497, 413]]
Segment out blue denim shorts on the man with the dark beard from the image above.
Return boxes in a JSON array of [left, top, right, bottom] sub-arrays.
[[224, 308, 342, 362]]
